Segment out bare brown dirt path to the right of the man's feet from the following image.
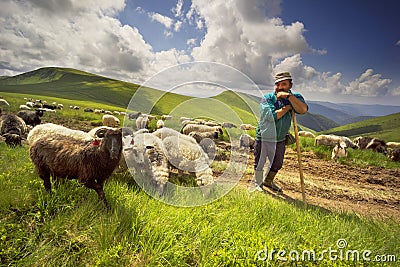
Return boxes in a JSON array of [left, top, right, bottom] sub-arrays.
[[241, 148, 400, 222]]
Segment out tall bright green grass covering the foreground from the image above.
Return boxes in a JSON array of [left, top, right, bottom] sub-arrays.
[[0, 143, 400, 266]]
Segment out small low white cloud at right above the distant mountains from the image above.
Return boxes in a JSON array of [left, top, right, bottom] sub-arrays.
[[343, 69, 392, 96]]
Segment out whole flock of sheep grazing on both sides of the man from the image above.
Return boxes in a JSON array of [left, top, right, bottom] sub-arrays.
[[0, 98, 400, 204]]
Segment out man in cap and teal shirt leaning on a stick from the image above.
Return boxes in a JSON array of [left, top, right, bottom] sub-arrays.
[[250, 72, 308, 192]]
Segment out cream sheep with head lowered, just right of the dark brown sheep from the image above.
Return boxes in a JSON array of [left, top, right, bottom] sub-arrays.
[[123, 132, 169, 194]]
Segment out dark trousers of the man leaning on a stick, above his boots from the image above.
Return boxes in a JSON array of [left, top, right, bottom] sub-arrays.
[[254, 140, 286, 172]]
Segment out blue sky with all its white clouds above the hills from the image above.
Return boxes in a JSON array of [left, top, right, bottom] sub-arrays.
[[0, 0, 400, 105]]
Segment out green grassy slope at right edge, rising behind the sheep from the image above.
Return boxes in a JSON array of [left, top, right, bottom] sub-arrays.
[[322, 113, 400, 142]]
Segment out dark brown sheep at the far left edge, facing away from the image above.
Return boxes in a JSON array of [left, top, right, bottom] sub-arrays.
[[0, 114, 28, 146]]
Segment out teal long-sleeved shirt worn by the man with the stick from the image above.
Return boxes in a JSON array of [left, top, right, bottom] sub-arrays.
[[256, 92, 308, 142]]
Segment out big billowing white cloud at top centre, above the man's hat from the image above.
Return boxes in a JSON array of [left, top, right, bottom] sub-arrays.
[[189, 0, 312, 84]]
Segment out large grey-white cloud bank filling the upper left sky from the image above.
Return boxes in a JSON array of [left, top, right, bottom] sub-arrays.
[[0, 0, 188, 82]]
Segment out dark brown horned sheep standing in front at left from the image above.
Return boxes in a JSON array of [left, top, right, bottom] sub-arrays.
[[29, 129, 122, 205]]
